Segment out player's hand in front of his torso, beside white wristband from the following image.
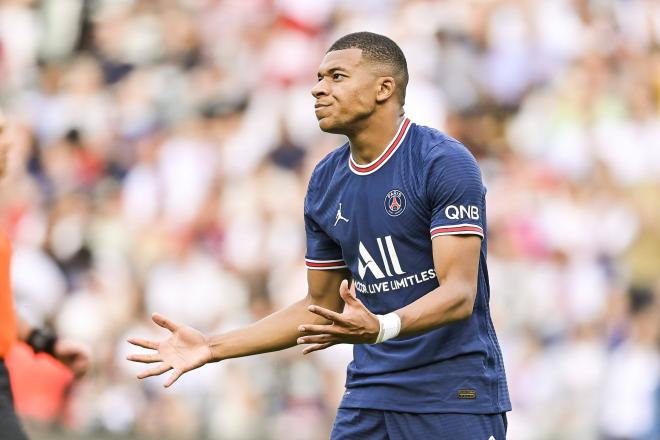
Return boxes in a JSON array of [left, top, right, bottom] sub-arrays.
[[297, 280, 380, 354]]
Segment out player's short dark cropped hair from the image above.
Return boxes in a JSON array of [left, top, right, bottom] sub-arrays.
[[326, 32, 408, 105]]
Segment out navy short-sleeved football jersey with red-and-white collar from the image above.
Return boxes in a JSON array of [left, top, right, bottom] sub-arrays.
[[305, 119, 511, 414]]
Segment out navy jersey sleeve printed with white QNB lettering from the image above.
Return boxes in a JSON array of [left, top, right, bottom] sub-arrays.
[[426, 140, 486, 239]]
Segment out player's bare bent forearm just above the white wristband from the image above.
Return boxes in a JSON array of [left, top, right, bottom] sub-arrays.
[[396, 281, 476, 336]]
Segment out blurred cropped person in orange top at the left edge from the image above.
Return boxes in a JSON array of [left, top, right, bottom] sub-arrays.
[[0, 113, 89, 440]]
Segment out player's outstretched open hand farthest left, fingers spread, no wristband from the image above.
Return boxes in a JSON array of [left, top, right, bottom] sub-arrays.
[[126, 313, 212, 387]]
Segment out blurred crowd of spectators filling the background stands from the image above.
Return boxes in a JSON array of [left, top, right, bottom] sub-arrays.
[[0, 0, 660, 440]]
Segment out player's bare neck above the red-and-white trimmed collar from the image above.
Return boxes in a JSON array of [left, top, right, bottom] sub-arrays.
[[347, 113, 405, 164]]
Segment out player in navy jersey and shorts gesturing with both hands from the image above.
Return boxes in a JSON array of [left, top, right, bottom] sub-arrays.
[[129, 32, 511, 440]]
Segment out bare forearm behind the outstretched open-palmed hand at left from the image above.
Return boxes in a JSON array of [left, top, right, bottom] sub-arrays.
[[209, 296, 336, 362]]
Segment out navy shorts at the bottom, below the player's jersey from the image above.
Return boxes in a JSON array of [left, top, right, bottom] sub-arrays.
[[330, 408, 507, 440]]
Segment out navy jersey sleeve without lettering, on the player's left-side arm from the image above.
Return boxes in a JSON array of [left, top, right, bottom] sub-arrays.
[[305, 171, 347, 270]]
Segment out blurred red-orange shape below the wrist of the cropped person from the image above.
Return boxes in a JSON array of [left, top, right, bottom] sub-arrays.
[[5, 342, 73, 422]]
